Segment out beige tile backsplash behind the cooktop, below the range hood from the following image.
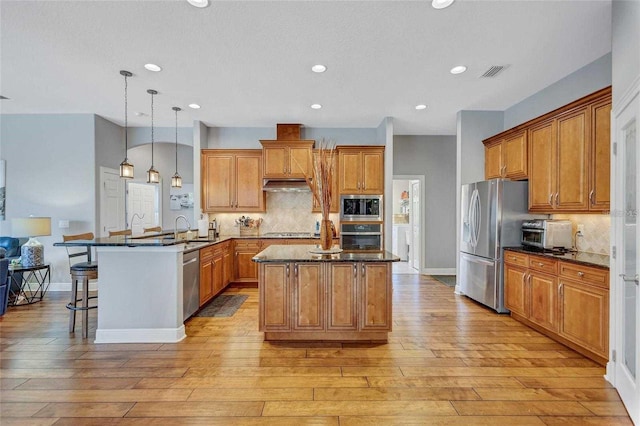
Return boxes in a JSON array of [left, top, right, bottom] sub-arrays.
[[209, 192, 340, 235]]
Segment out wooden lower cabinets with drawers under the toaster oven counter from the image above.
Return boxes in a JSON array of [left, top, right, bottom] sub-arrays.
[[504, 250, 609, 364]]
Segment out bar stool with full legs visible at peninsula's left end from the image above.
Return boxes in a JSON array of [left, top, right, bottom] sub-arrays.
[[62, 232, 98, 339]]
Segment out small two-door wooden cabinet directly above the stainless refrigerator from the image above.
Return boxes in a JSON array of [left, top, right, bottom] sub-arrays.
[[483, 130, 528, 180]]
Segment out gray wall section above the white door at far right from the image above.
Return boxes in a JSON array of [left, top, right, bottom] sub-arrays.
[[611, 0, 640, 103]]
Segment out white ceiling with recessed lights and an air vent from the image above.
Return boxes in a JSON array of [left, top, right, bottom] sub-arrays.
[[0, 0, 611, 134]]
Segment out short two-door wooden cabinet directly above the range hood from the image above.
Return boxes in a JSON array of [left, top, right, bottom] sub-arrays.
[[260, 140, 315, 179]]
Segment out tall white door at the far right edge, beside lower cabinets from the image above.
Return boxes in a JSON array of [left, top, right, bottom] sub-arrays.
[[610, 87, 640, 424]]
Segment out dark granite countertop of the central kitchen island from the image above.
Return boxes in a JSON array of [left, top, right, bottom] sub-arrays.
[[252, 244, 400, 263]]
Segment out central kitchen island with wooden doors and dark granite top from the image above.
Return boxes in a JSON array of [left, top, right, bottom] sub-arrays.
[[253, 245, 400, 341]]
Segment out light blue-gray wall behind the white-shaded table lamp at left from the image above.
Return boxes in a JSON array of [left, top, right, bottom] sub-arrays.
[[0, 114, 96, 283]]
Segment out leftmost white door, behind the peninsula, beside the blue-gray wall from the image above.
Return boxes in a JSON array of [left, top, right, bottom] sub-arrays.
[[97, 167, 125, 237]]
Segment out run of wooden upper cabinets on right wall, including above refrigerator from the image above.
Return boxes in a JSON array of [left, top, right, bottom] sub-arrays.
[[483, 87, 611, 213]]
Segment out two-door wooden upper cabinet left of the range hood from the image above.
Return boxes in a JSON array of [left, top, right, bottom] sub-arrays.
[[201, 149, 265, 213]]
